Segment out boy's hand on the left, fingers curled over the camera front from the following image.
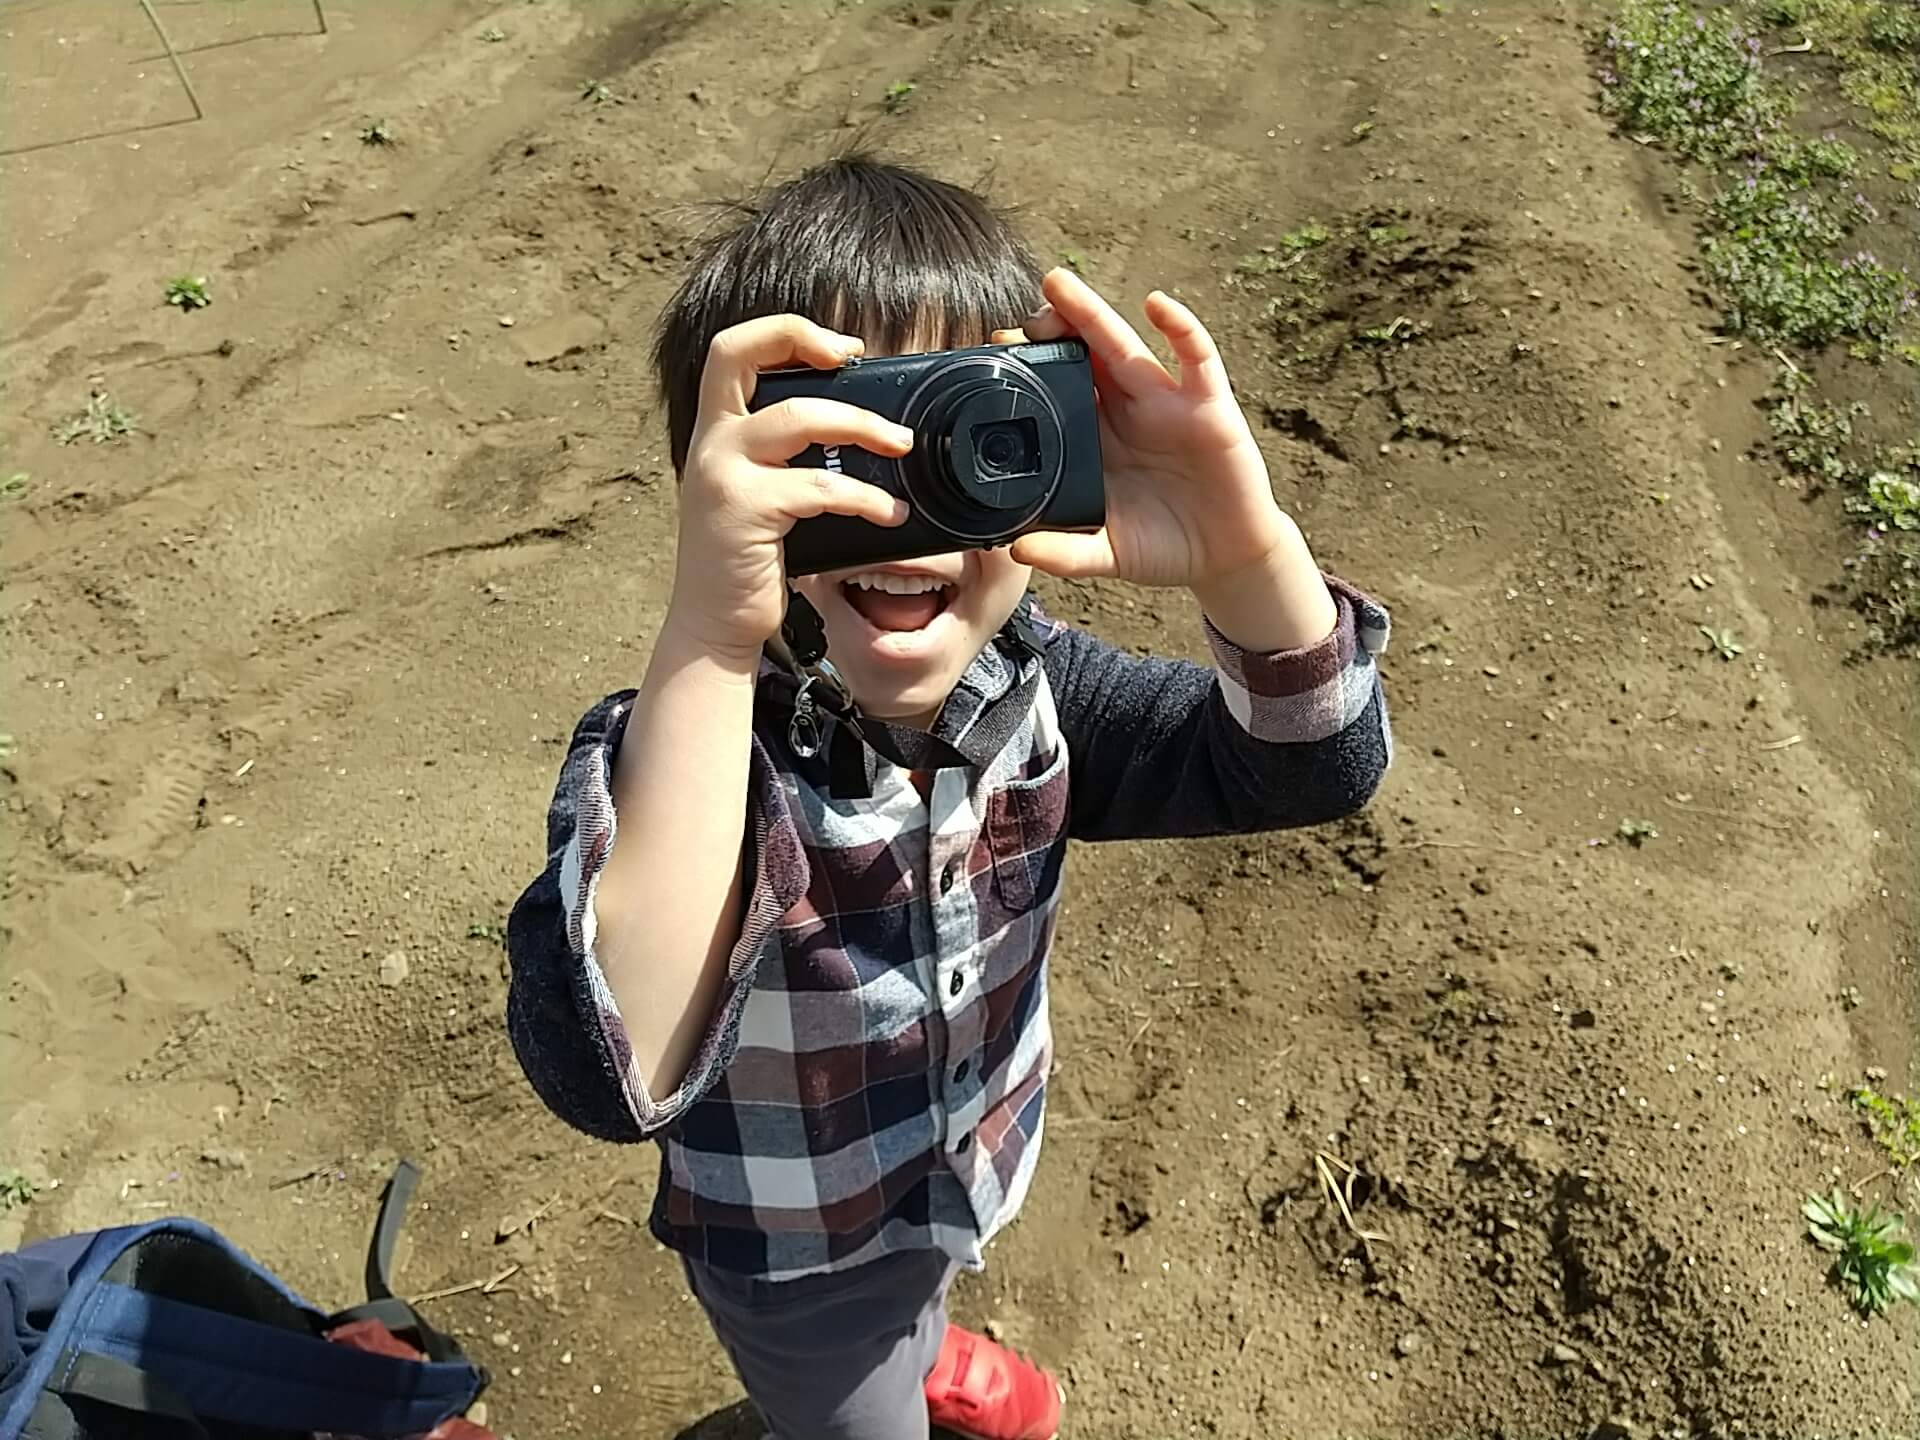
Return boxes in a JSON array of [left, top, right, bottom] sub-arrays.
[[666, 315, 914, 668]]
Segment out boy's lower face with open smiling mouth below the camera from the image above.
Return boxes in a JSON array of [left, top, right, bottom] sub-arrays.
[[793, 549, 1033, 728]]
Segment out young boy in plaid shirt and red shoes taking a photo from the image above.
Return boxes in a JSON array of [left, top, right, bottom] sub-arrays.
[[507, 159, 1390, 1440]]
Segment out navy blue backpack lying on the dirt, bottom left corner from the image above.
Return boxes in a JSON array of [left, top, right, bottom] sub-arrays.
[[0, 1160, 488, 1440]]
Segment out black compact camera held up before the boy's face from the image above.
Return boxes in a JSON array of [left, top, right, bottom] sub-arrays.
[[753, 340, 1106, 574]]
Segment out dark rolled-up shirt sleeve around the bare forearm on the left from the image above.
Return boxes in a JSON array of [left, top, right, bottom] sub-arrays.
[[507, 691, 806, 1140]]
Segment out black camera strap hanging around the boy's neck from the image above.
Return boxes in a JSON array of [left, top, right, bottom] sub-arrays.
[[768, 589, 1046, 799]]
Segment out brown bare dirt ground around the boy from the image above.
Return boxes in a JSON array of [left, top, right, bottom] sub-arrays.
[[0, 0, 1920, 1440]]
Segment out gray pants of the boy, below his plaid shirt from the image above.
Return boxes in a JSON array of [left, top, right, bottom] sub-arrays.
[[682, 1250, 958, 1440]]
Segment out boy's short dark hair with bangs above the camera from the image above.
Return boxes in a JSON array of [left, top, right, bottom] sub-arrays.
[[653, 156, 1041, 472]]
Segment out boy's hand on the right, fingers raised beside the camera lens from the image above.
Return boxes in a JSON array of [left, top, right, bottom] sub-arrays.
[[993, 269, 1336, 651]]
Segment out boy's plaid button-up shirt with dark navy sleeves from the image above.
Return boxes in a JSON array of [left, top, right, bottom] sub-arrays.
[[509, 580, 1390, 1281]]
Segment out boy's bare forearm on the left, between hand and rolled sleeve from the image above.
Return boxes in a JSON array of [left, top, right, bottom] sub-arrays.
[[593, 616, 755, 1100]]
